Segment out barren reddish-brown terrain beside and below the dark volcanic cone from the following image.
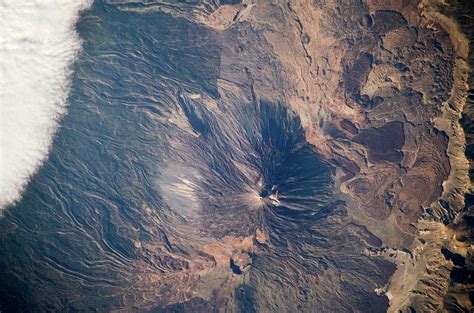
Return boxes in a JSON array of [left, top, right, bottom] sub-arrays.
[[107, 0, 472, 312]]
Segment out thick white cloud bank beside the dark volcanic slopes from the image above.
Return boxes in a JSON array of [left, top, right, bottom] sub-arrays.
[[0, 0, 90, 214]]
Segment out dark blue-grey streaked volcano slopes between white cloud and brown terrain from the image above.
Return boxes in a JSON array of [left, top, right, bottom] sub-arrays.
[[0, 3, 394, 312]]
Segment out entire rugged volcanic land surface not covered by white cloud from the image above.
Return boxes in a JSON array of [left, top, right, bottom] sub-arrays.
[[0, 0, 474, 312]]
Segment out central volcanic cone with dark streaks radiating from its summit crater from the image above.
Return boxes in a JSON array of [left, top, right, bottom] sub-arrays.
[[168, 99, 332, 237]]
